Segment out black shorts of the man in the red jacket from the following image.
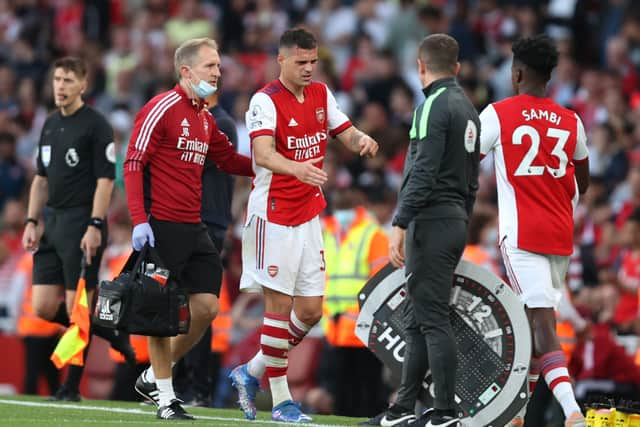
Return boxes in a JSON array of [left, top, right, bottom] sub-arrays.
[[149, 218, 222, 296]]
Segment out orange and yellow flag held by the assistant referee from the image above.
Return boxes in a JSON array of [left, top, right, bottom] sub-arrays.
[[51, 257, 91, 369]]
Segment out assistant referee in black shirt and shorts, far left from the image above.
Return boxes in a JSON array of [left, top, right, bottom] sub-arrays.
[[22, 57, 133, 400]]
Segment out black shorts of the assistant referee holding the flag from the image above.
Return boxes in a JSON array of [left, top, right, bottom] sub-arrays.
[[33, 206, 108, 291]]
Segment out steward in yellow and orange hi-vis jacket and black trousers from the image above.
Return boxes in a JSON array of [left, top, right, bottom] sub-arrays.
[[322, 189, 389, 417]]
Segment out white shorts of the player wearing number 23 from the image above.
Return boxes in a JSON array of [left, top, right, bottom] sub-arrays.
[[500, 239, 569, 309]]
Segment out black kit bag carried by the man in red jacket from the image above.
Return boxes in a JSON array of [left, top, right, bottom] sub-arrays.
[[93, 245, 191, 337]]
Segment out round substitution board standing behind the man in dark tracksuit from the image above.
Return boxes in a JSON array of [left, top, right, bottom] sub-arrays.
[[356, 261, 531, 427]]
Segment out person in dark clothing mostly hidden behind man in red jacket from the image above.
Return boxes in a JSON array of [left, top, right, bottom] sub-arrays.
[[175, 78, 238, 407]]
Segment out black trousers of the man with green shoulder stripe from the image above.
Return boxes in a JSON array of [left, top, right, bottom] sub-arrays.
[[396, 218, 467, 410]]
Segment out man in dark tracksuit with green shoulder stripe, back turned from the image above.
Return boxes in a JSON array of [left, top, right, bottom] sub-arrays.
[[380, 34, 480, 427]]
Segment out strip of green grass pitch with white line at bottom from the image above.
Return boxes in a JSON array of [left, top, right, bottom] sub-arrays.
[[0, 396, 363, 427]]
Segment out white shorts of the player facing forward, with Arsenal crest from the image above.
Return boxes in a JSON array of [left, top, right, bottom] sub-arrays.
[[240, 215, 325, 297]]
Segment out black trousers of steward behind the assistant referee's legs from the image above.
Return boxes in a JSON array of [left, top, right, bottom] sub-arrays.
[[22, 335, 60, 394]]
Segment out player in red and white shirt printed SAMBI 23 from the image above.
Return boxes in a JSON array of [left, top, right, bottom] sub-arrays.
[[480, 35, 589, 427]]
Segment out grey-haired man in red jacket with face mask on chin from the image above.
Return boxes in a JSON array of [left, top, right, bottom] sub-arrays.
[[124, 38, 253, 419]]
